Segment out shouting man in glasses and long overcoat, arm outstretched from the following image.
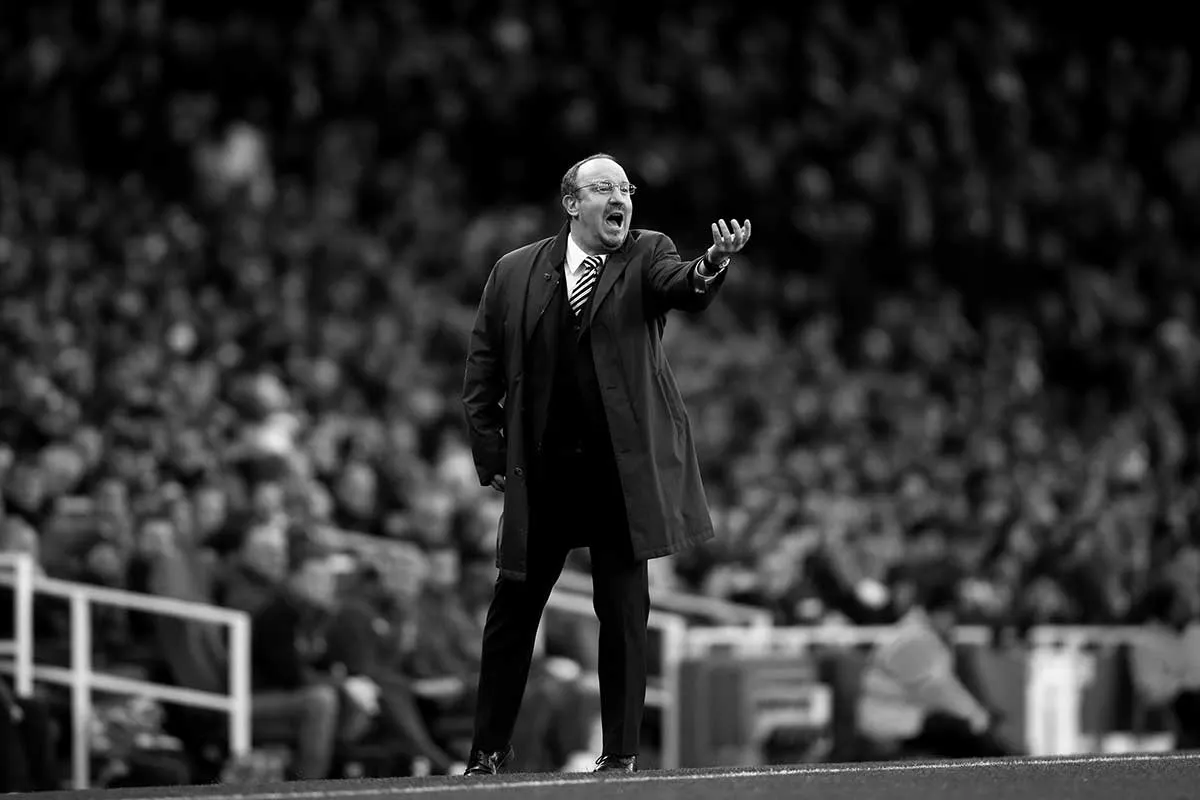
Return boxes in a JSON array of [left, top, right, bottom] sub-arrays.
[[463, 154, 750, 775]]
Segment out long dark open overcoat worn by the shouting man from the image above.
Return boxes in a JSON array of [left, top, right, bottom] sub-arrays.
[[462, 225, 725, 579]]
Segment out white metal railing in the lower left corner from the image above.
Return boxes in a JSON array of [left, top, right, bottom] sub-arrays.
[[0, 553, 251, 789]]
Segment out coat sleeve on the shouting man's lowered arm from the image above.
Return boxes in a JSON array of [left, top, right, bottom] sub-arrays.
[[462, 264, 508, 486]]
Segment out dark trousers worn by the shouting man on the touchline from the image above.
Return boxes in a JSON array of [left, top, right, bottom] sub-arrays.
[[475, 451, 650, 756]]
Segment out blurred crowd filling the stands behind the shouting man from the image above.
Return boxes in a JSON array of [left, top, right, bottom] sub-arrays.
[[0, 0, 1200, 782]]
